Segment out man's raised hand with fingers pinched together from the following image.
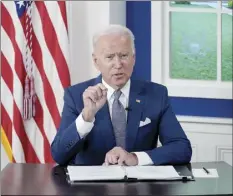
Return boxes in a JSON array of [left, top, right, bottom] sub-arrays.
[[82, 83, 107, 122]]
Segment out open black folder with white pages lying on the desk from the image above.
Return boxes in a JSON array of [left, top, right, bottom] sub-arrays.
[[66, 165, 193, 183]]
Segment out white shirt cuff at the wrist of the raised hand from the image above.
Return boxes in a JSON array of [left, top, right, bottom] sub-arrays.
[[75, 112, 95, 139]]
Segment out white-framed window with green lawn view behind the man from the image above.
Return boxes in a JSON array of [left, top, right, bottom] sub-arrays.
[[151, 1, 233, 99]]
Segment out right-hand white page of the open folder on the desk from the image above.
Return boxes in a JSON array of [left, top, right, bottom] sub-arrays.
[[124, 166, 181, 180]]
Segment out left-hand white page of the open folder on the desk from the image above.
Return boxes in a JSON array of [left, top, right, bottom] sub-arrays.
[[67, 165, 125, 181]]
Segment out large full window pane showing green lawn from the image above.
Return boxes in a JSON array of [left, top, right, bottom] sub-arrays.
[[170, 12, 217, 80]]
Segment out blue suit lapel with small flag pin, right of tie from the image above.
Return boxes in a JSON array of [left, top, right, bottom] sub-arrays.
[[126, 80, 145, 152]]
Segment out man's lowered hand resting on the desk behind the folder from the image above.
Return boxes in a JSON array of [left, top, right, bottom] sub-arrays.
[[103, 147, 138, 166]]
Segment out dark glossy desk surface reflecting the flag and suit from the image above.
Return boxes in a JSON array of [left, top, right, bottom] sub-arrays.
[[1, 162, 233, 195]]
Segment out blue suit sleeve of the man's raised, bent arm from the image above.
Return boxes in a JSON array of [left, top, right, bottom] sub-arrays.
[[51, 89, 85, 165]]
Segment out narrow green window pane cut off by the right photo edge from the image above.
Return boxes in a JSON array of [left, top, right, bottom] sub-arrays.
[[222, 14, 233, 81]]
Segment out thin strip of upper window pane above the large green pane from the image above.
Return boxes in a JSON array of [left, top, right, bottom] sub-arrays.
[[170, 1, 218, 8]]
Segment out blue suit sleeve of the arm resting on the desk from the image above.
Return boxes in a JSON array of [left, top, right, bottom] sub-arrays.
[[146, 88, 192, 165]]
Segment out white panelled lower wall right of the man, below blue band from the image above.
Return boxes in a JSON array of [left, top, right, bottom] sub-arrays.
[[178, 116, 232, 165]]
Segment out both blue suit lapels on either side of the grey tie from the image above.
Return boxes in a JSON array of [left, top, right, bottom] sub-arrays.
[[95, 75, 145, 152]]
